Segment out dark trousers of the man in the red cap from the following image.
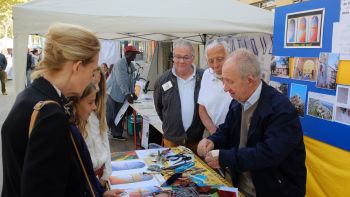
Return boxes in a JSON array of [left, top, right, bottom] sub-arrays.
[[106, 95, 123, 137]]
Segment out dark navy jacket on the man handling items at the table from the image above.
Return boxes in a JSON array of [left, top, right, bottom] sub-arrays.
[[209, 82, 306, 197]]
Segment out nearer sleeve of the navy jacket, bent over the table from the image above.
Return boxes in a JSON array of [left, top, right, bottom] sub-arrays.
[[219, 106, 303, 172]]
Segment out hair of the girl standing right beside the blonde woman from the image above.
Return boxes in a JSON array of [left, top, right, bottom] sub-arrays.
[[70, 83, 97, 138]]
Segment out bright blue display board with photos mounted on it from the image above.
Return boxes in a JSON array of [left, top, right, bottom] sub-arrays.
[[271, 0, 350, 151]]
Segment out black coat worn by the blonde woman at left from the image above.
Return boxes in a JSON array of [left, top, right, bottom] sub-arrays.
[[1, 78, 89, 197]]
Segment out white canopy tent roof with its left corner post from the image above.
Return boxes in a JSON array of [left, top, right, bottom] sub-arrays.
[[13, 0, 274, 93]]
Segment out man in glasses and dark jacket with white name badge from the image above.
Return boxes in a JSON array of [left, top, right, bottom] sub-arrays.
[[154, 39, 204, 152]]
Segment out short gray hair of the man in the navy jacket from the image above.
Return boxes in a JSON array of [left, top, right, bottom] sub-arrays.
[[230, 49, 261, 79]]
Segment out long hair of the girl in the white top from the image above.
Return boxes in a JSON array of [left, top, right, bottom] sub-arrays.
[[96, 67, 107, 136]]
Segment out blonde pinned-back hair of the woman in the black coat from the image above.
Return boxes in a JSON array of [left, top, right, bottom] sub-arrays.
[[31, 23, 100, 79]]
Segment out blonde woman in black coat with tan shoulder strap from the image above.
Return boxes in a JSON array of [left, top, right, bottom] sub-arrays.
[[1, 24, 116, 197]]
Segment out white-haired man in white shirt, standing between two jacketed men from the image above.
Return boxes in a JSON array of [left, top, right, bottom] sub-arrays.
[[198, 38, 232, 137]]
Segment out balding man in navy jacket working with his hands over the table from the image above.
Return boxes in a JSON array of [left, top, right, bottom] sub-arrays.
[[197, 50, 306, 197]]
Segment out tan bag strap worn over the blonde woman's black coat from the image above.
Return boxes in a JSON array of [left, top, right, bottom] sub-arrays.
[[28, 100, 96, 197]]
